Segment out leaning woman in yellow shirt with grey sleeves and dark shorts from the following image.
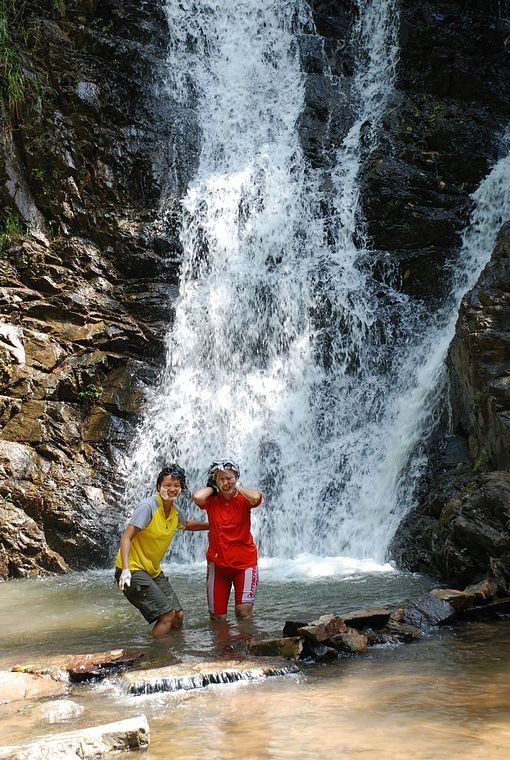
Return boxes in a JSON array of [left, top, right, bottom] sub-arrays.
[[115, 464, 209, 638]]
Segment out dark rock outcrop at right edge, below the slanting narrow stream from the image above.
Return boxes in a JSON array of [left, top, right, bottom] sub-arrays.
[[394, 223, 510, 593]]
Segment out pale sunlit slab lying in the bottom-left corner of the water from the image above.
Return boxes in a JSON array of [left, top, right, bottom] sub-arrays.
[[0, 715, 150, 760]]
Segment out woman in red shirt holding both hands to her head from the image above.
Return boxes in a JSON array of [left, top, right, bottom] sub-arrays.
[[193, 459, 263, 620]]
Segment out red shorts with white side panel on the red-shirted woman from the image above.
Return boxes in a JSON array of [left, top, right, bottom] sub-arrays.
[[207, 562, 259, 615]]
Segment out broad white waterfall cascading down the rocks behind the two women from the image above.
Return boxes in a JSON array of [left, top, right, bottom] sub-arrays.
[[123, 0, 510, 569]]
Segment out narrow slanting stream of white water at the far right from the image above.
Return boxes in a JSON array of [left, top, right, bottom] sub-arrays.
[[360, 134, 510, 546]]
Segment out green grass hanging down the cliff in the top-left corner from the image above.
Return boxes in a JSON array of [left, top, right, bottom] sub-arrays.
[[0, 0, 26, 114]]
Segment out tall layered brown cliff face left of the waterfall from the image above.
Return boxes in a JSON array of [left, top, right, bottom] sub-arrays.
[[0, 0, 179, 578]]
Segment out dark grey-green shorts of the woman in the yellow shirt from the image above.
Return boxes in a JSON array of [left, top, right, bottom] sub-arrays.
[[115, 568, 182, 623]]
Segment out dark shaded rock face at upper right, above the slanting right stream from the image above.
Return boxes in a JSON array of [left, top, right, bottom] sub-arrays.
[[361, 0, 510, 308]]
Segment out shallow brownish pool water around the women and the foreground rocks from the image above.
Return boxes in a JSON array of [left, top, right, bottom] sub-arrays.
[[0, 562, 510, 760]]
